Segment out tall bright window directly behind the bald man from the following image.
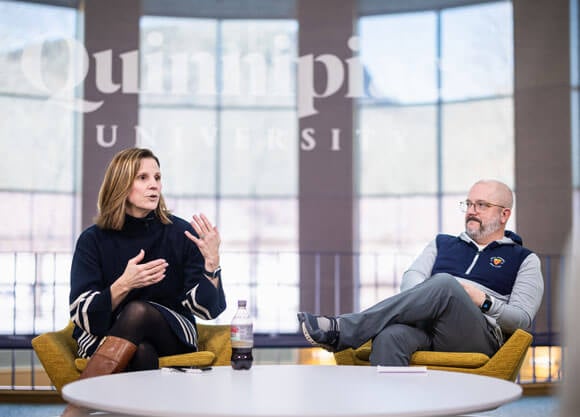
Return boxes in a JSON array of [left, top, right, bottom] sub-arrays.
[[357, 1, 514, 307]]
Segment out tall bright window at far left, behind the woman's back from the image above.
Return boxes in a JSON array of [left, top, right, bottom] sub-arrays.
[[0, 1, 79, 333]]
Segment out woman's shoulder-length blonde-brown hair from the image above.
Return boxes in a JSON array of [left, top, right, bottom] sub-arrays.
[[95, 148, 171, 230]]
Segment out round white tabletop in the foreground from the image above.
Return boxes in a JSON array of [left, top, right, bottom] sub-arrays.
[[62, 365, 522, 417]]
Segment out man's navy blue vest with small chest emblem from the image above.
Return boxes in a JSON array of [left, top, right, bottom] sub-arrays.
[[431, 232, 532, 295]]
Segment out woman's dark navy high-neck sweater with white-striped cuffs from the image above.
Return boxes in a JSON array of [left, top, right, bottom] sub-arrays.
[[69, 212, 226, 356]]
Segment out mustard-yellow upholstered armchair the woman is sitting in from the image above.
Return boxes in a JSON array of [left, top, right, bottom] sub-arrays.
[[32, 322, 232, 393]]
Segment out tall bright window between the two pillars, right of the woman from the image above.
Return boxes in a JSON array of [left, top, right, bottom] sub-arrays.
[[139, 16, 298, 332]]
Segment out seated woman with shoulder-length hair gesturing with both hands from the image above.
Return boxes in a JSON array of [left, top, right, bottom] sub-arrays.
[[65, 148, 226, 400]]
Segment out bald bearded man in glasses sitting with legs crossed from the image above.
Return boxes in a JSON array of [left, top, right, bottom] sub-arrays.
[[298, 180, 544, 366]]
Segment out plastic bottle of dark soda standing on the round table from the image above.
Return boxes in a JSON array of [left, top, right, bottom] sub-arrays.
[[231, 300, 254, 369]]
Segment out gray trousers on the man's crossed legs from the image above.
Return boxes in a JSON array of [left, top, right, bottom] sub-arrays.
[[337, 274, 500, 366]]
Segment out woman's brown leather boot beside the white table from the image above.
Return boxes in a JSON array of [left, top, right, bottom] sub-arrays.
[[61, 336, 137, 417]]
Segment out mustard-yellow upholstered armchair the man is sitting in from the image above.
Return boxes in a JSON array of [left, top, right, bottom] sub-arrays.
[[334, 329, 532, 381]]
